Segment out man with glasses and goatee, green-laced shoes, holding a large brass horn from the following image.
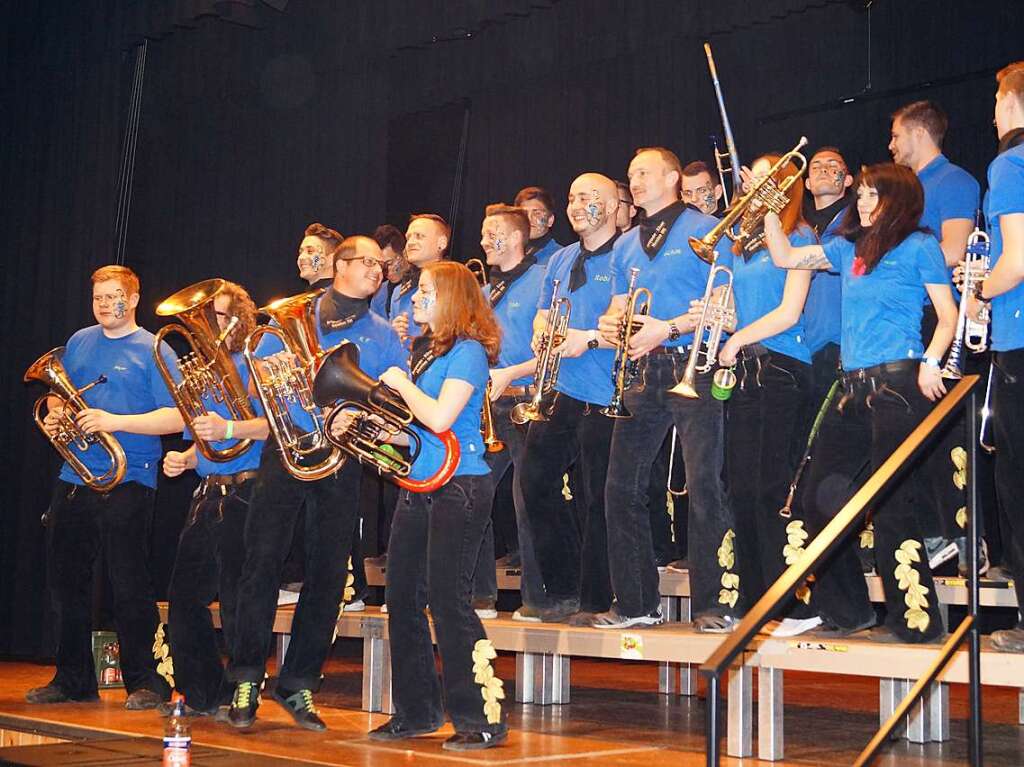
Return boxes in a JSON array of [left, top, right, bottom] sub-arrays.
[[227, 237, 406, 730]]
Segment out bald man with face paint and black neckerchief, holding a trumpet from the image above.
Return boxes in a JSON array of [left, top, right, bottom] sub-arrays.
[[520, 173, 618, 623]]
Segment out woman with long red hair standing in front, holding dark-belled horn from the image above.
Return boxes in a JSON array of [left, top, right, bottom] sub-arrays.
[[370, 261, 508, 751]]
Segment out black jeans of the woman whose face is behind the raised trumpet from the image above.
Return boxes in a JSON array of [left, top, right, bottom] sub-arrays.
[[726, 349, 811, 609]]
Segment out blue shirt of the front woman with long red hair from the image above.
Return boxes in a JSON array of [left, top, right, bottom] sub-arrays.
[[410, 338, 490, 479]]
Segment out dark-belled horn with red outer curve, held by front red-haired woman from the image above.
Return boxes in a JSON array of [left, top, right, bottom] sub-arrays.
[[312, 342, 461, 493]]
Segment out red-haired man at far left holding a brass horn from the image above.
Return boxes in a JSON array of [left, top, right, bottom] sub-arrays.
[[26, 266, 182, 710]]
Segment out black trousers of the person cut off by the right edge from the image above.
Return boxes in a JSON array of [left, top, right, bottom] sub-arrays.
[[991, 349, 1024, 629]]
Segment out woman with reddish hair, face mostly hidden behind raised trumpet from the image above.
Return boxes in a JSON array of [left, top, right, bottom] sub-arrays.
[[719, 155, 819, 635]]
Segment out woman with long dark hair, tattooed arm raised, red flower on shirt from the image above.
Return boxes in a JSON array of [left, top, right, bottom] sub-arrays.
[[765, 164, 956, 642]]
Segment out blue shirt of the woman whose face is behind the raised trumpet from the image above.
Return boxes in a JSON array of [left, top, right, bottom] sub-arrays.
[[732, 224, 817, 364]]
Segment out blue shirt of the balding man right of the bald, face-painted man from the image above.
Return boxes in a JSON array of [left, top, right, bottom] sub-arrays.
[[611, 207, 732, 346]]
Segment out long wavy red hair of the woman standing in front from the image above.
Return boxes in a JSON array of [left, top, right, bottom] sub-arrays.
[[423, 261, 502, 365]]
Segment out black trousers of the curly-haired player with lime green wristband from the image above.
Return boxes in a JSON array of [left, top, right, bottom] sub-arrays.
[[167, 479, 256, 711]]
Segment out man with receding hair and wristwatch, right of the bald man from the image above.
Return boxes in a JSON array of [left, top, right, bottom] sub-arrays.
[[594, 147, 735, 631]]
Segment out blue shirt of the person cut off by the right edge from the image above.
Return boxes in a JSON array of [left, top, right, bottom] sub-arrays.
[[985, 144, 1024, 351]]
